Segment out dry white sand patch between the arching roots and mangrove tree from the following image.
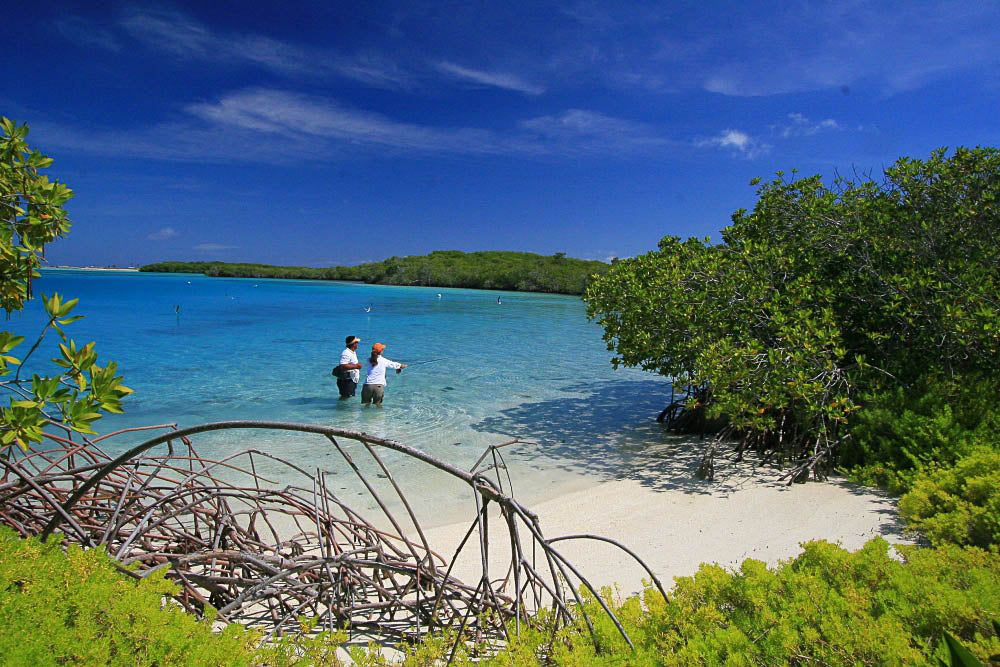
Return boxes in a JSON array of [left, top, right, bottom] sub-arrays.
[[427, 448, 911, 595]]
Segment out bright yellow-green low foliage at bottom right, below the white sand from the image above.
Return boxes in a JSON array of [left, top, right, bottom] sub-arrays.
[[356, 538, 1000, 665]]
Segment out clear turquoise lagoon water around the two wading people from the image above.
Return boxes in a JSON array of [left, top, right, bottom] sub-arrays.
[[17, 269, 670, 516]]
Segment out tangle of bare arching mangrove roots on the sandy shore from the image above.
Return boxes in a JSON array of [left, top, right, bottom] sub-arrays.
[[0, 421, 665, 653]]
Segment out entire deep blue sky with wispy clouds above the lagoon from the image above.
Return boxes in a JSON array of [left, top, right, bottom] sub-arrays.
[[7, 0, 1000, 266]]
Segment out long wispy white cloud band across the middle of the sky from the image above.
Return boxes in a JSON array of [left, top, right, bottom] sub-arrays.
[[37, 88, 680, 164]]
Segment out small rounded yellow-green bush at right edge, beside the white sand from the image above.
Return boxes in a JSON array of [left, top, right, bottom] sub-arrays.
[[899, 448, 1000, 547]]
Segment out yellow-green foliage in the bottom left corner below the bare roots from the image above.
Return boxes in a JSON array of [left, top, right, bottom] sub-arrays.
[[0, 527, 344, 666]]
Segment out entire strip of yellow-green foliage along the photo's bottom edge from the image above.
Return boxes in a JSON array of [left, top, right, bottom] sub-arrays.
[[7, 528, 1000, 665]]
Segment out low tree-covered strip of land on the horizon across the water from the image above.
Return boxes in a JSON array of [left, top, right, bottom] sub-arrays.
[[139, 250, 610, 294]]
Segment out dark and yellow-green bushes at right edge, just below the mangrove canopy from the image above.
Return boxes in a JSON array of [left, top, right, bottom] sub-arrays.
[[842, 377, 1000, 548]]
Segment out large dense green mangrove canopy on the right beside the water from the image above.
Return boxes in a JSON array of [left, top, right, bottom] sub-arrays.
[[584, 148, 1000, 478]]
